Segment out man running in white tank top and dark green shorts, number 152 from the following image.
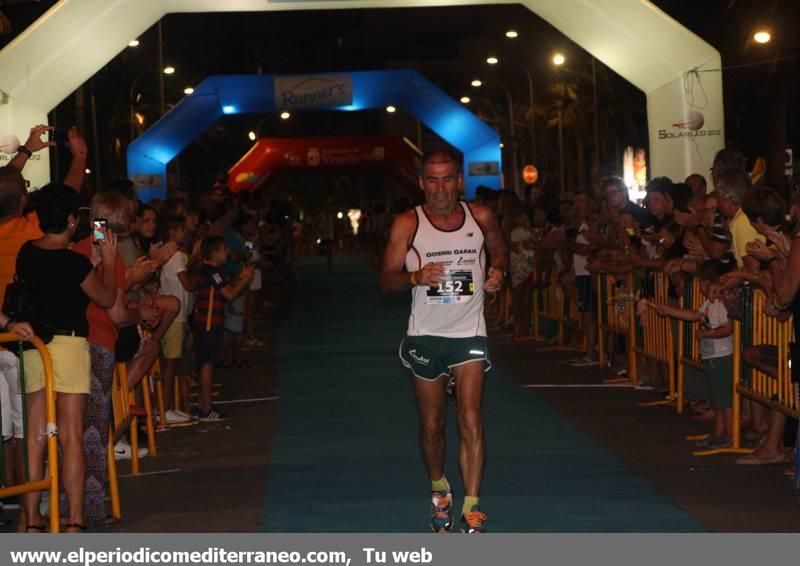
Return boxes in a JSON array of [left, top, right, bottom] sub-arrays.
[[380, 151, 508, 533]]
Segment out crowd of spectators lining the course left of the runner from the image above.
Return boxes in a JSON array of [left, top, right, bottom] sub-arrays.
[[0, 126, 291, 532]]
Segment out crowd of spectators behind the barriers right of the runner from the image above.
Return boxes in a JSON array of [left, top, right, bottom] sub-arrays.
[[479, 148, 800, 474]]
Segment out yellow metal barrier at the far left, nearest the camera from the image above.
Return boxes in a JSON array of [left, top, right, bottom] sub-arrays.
[[0, 332, 59, 533]]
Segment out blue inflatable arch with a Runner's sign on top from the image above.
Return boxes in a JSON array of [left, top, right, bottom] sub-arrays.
[[128, 70, 502, 201]]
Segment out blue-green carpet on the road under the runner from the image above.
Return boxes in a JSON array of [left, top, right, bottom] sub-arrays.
[[262, 258, 701, 532]]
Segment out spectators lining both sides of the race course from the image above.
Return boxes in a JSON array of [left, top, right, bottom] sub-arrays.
[[0, 126, 800, 532]]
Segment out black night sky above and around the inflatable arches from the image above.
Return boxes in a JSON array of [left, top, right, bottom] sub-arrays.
[[0, 0, 800, 191]]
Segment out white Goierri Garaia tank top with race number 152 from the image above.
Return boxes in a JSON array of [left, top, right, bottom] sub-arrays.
[[406, 202, 486, 338]]
